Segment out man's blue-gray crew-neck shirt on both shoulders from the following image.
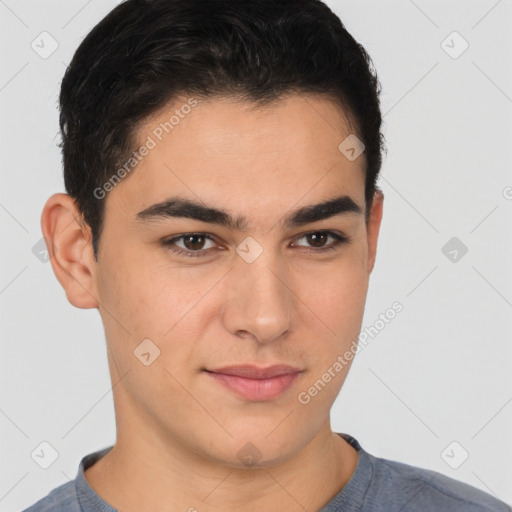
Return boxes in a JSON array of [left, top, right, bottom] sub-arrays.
[[24, 433, 512, 512]]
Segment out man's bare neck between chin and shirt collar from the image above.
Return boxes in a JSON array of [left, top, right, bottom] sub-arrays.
[[85, 421, 357, 512]]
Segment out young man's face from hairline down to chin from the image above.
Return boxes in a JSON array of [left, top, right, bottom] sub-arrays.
[[69, 95, 381, 466]]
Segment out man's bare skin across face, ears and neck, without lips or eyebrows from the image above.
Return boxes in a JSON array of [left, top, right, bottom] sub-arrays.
[[41, 94, 383, 512]]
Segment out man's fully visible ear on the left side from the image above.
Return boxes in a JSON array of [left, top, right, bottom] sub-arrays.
[[41, 193, 98, 309]]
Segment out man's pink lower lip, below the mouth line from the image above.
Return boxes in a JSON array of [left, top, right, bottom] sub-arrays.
[[206, 372, 299, 402]]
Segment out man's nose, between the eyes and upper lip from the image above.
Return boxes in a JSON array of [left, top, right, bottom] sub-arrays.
[[223, 251, 296, 343]]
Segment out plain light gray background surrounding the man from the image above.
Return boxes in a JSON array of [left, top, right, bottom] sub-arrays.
[[0, 0, 512, 511]]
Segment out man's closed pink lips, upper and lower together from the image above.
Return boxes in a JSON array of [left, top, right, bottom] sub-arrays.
[[205, 365, 302, 402]]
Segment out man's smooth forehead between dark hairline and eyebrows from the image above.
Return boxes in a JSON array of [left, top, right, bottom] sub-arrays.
[[107, 94, 365, 224]]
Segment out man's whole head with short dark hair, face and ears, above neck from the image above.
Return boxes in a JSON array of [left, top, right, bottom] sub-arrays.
[[42, 0, 384, 465]]
